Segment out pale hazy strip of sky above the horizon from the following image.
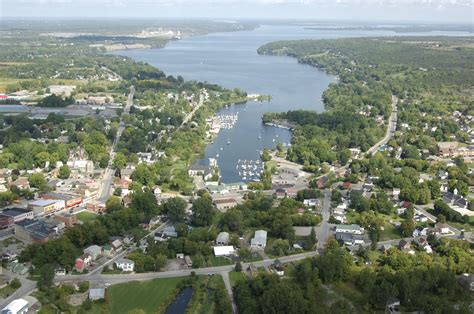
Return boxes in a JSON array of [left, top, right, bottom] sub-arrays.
[[0, 0, 474, 24]]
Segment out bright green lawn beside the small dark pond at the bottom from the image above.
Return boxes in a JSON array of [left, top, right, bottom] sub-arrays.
[[107, 278, 183, 313]]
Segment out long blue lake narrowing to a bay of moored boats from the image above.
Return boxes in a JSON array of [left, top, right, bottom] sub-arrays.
[[117, 25, 472, 183]]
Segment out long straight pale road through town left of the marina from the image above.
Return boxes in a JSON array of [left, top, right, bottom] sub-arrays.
[[99, 86, 135, 203]]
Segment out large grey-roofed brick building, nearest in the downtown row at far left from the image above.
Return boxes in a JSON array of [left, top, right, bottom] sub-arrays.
[[14, 219, 57, 243]]
